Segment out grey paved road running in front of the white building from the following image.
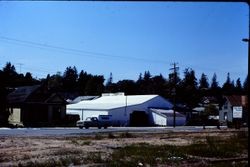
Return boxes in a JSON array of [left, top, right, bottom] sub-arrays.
[[0, 126, 226, 137]]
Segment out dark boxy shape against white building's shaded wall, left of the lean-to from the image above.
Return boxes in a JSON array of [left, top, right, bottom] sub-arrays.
[[130, 111, 149, 127]]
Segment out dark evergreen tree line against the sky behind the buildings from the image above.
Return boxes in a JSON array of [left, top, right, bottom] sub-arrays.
[[0, 62, 248, 124]]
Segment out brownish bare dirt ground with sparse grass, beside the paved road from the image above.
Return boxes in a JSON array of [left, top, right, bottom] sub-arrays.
[[0, 130, 248, 167]]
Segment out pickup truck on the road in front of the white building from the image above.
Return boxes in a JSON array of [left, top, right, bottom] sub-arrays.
[[76, 115, 112, 129]]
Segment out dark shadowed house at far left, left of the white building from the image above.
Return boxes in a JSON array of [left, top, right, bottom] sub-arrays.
[[7, 85, 66, 126]]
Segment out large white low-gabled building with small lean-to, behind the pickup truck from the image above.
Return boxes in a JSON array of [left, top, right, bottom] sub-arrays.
[[67, 93, 186, 126]]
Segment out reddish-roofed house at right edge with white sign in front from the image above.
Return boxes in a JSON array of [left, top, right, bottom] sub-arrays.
[[219, 95, 248, 123]]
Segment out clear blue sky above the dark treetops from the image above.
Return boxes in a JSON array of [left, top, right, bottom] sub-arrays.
[[0, 1, 249, 85]]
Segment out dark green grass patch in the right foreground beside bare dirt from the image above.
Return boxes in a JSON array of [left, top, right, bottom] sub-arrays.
[[108, 132, 248, 167]]
